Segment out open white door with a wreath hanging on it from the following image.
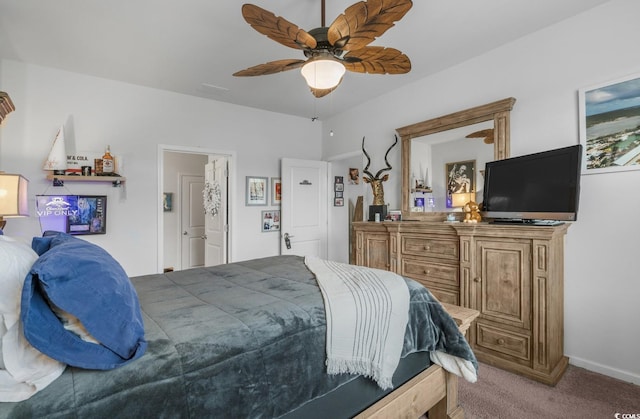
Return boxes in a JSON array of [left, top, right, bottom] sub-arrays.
[[204, 157, 229, 266]]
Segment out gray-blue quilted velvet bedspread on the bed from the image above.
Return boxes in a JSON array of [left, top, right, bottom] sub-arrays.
[[0, 256, 477, 418]]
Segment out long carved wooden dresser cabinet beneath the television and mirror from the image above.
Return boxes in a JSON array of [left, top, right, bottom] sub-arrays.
[[354, 221, 568, 384]]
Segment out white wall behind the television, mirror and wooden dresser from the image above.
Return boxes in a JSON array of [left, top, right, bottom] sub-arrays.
[[323, 0, 640, 383]]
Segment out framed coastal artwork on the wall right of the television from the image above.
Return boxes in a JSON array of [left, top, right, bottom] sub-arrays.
[[578, 74, 640, 174]]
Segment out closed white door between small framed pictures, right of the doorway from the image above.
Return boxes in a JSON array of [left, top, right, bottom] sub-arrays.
[[280, 159, 329, 259]]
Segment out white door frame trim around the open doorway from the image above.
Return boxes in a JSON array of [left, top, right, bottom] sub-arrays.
[[156, 144, 236, 273]]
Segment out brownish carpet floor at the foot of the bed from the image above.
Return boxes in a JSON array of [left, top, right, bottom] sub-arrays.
[[459, 364, 640, 419]]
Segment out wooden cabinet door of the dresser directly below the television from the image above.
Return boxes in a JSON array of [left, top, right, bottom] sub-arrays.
[[474, 238, 531, 330]]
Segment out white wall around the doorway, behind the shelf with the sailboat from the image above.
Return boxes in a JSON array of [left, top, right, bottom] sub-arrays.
[[0, 60, 321, 276]]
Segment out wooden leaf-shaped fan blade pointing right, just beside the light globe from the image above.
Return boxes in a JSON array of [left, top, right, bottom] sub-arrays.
[[342, 47, 411, 74]]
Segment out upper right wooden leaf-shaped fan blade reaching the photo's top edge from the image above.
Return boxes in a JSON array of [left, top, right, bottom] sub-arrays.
[[327, 0, 413, 51]]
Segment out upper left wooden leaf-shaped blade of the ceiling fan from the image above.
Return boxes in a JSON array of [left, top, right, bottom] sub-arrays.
[[242, 4, 317, 49]]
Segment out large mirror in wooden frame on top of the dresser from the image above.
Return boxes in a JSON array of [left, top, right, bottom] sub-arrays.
[[396, 97, 516, 221]]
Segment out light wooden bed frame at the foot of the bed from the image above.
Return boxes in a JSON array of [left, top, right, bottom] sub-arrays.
[[355, 303, 480, 419]]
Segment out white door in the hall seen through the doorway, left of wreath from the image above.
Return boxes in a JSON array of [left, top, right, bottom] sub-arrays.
[[180, 175, 204, 269]]
